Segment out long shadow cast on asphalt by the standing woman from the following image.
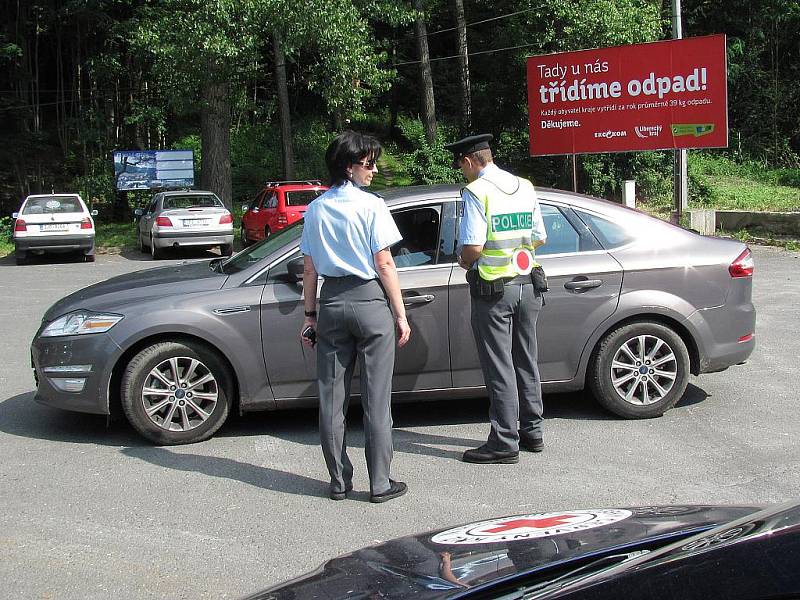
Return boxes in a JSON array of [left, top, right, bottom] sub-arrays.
[[121, 447, 328, 497]]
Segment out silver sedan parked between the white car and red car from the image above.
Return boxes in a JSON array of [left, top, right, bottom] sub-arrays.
[[134, 190, 233, 259]]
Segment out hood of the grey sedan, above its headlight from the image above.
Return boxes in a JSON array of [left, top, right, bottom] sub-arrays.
[[43, 261, 228, 321]]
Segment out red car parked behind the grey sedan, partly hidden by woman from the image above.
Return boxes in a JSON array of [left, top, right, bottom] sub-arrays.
[[241, 180, 328, 247]]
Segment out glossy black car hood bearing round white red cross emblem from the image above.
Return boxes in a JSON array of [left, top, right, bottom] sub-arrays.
[[250, 506, 759, 600]]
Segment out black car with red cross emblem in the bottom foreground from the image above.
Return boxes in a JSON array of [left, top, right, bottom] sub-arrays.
[[244, 503, 800, 600]]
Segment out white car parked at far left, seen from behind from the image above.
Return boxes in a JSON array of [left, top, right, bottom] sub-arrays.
[[12, 194, 97, 265]]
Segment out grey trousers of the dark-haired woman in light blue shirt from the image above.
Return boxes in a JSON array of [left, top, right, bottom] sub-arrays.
[[317, 277, 396, 494]]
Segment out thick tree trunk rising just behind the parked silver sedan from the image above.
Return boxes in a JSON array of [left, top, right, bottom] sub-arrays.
[[200, 62, 233, 209]]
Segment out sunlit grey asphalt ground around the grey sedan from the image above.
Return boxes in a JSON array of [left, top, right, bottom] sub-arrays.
[[0, 246, 800, 600]]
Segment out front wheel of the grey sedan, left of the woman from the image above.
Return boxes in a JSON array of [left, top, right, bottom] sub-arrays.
[[121, 342, 233, 446]]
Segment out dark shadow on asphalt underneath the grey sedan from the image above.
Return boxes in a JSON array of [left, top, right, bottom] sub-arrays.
[[0, 384, 709, 450]]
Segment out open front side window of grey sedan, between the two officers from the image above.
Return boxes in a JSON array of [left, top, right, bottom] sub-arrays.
[[392, 206, 441, 268]]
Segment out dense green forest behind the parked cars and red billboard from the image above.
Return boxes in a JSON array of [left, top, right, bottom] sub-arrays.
[[0, 0, 800, 218]]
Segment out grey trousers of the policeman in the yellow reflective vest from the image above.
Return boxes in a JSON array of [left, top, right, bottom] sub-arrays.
[[472, 284, 544, 452]]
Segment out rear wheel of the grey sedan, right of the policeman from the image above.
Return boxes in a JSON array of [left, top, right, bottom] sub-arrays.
[[589, 322, 690, 419]]
